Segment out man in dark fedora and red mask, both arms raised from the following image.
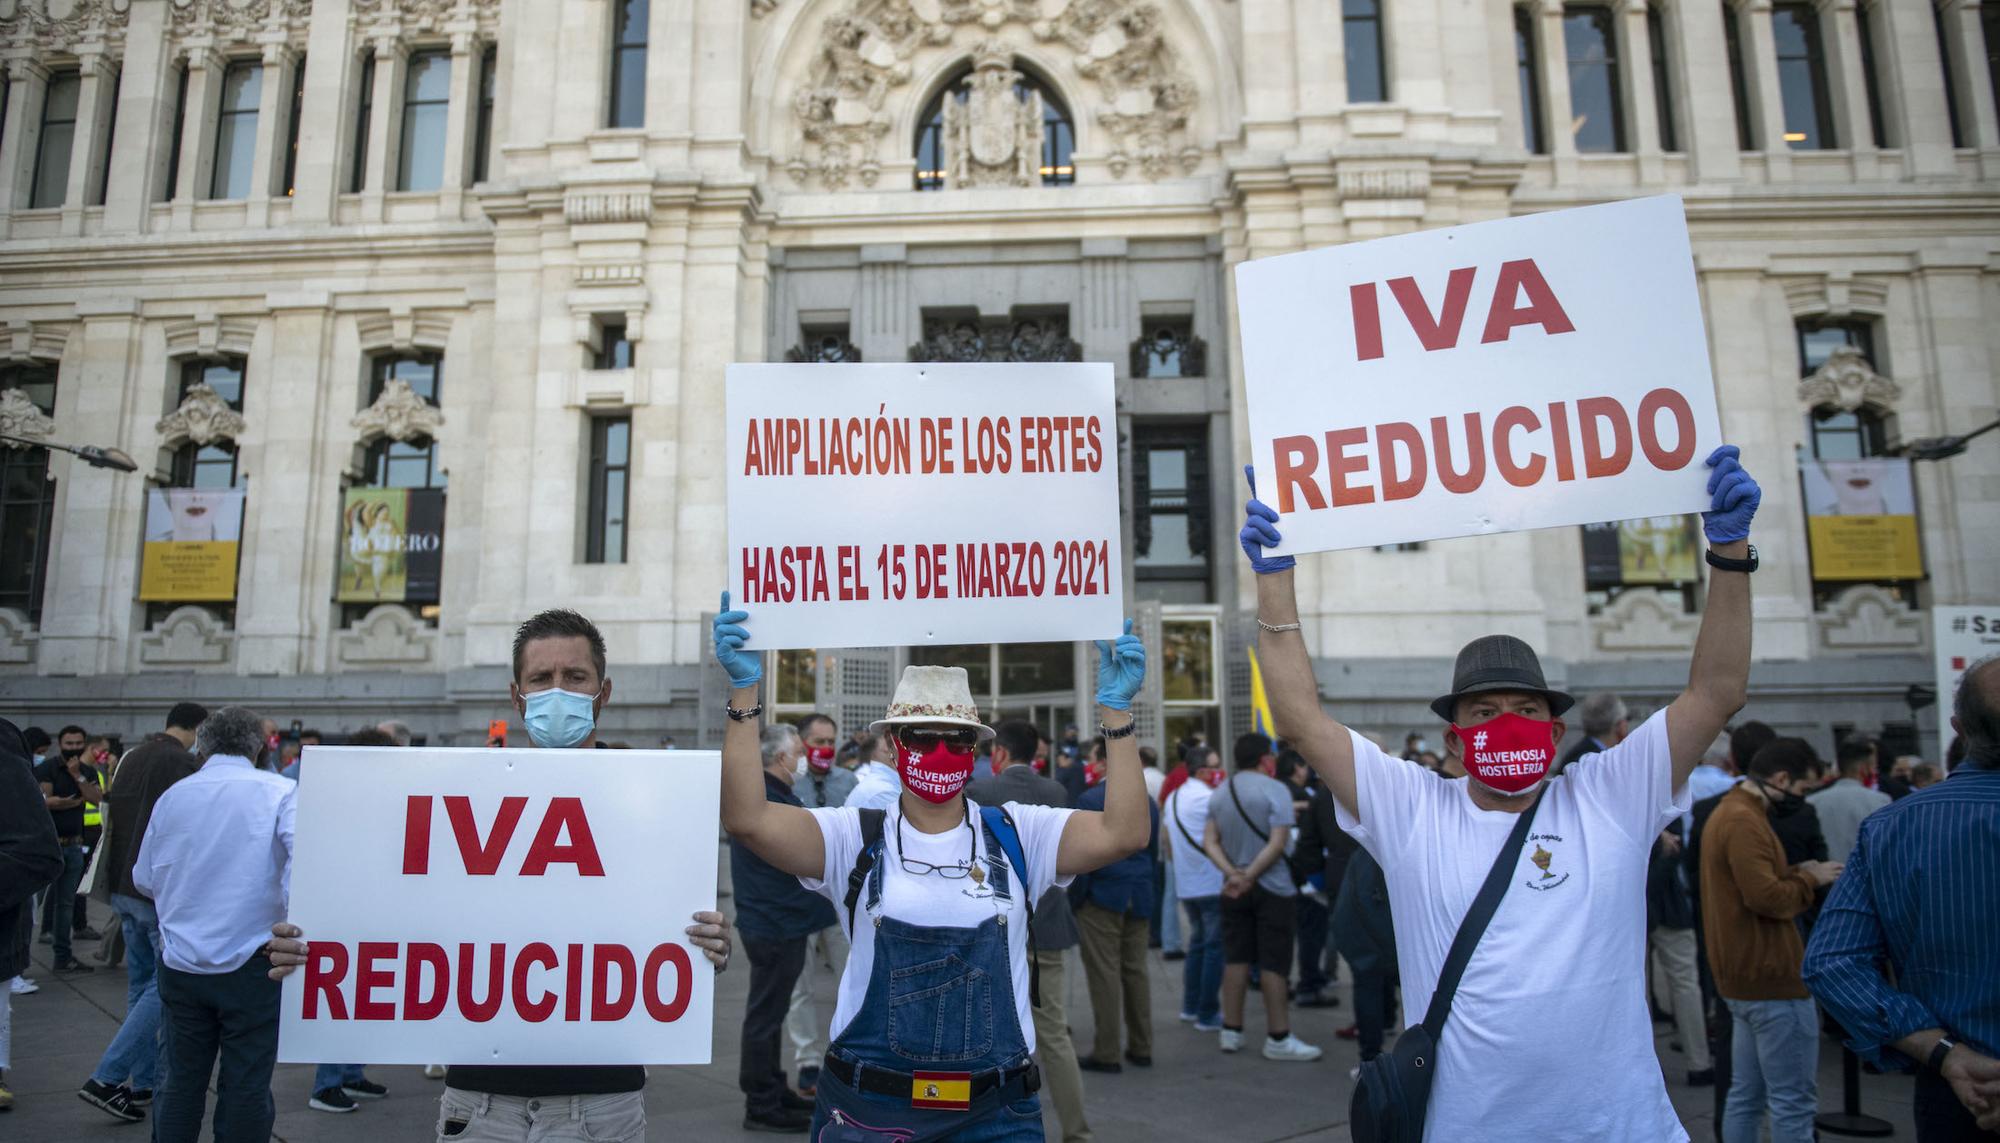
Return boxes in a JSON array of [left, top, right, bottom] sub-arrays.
[[1242, 446, 1762, 1141]]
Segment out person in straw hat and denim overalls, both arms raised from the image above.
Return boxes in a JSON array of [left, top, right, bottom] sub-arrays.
[[714, 593, 1150, 1143]]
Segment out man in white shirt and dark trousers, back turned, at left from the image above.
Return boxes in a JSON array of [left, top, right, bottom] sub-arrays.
[[132, 707, 298, 1143]]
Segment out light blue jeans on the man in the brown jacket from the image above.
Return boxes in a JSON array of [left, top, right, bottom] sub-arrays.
[[1722, 999, 1820, 1143]]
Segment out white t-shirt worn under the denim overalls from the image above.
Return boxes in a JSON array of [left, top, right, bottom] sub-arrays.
[[798, 799, 1076, 1051]]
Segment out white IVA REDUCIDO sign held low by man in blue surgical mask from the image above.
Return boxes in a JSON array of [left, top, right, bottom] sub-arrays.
[[278, 745, 722, 1065]]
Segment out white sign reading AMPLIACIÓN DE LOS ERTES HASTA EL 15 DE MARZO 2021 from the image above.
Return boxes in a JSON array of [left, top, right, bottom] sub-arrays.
[[726, 362, 1124, 649]]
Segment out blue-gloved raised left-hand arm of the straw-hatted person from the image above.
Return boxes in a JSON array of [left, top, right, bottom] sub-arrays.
[[714, 591, 826, 877]]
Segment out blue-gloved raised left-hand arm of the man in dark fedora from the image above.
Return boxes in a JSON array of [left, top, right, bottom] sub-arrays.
[[1238, 466, 1368, 817]]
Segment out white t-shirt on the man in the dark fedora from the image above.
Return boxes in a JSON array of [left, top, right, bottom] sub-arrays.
[[1336, 711, 1688, 1143]]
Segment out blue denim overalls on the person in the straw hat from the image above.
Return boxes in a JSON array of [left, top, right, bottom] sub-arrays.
[[808, 811, 1042, 1143]]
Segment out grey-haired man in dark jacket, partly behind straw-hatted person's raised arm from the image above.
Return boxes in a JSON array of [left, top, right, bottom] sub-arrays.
[[730, 723, 840, 1133]]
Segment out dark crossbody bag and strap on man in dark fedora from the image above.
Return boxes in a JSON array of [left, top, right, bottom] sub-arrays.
[[1348, 797, 1542, 1143]]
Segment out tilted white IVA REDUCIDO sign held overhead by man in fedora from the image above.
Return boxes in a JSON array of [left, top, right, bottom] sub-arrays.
[[1236, 196, 1720, 552]]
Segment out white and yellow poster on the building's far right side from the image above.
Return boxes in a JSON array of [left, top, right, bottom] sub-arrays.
[[1798, 456, 1924, 579]]
